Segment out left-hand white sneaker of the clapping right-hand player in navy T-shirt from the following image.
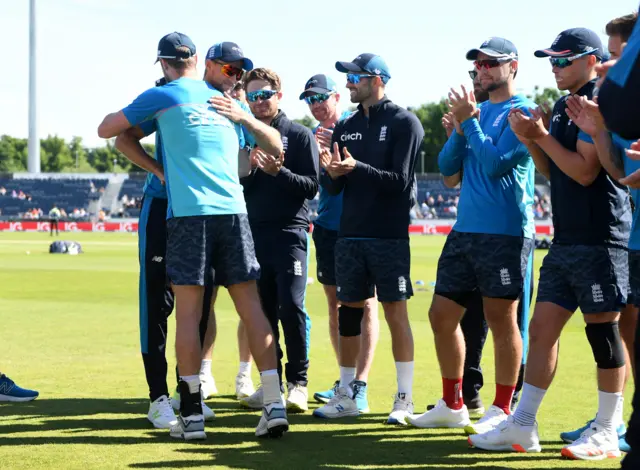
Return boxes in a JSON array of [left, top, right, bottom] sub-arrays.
[[467, 416, 542, 452]]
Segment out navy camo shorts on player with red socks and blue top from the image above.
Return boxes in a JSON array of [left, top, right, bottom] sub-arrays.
[[435, 230, 534, 303]]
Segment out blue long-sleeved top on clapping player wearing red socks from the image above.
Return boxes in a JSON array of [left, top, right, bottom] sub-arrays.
[[438, 95, 536, 238]]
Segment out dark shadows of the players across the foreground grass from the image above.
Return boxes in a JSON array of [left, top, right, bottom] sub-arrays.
[[0, 398, 620, 470]]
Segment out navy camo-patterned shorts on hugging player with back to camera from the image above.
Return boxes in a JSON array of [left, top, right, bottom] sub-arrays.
[[167, 214, 260, 287]]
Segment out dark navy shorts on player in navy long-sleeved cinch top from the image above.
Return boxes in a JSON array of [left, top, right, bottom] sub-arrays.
[[335, 238, 413, 302]]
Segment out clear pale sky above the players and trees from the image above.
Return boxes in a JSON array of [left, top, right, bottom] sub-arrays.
[[0, 0, 638, 147]]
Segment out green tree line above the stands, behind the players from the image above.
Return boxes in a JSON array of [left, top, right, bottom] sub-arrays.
[[0, 87, 561, 173]]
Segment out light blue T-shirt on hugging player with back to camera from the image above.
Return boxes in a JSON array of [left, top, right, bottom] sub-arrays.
[[123, 77, 247, 217]]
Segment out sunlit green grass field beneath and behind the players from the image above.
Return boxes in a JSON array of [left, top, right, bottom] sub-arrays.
[[0, 233, 633, 470]]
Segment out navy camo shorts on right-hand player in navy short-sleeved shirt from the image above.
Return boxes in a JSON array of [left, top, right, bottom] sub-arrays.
[[536, 243, 629, 313]]
